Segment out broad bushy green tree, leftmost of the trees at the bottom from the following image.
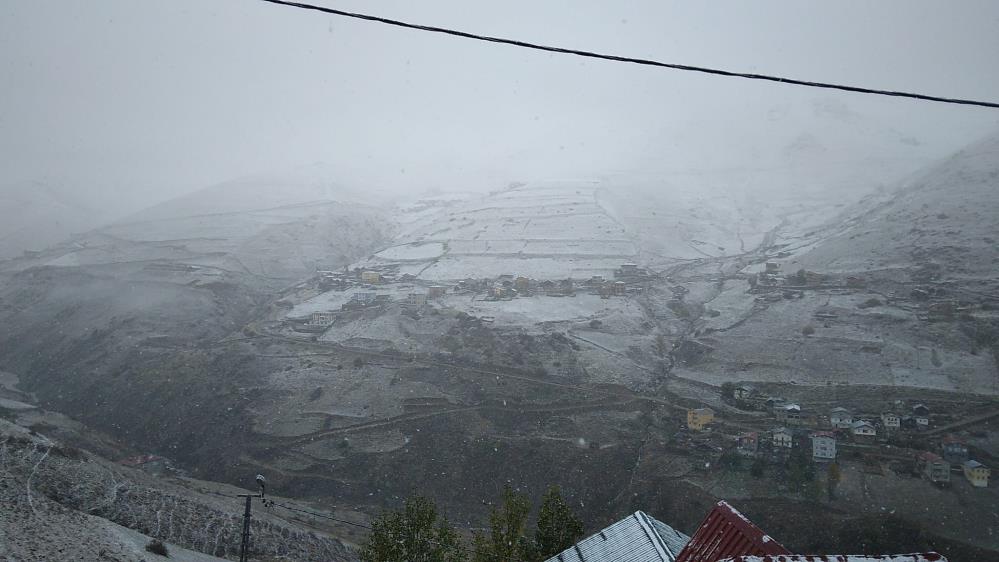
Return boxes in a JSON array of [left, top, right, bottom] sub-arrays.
[[361, 496, 465, 562]]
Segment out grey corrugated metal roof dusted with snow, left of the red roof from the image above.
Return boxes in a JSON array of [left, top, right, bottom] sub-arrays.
[[546, 511, 690, 562]]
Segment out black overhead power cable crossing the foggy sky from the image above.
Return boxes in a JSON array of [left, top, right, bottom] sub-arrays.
[[260, 0, 999, 108]]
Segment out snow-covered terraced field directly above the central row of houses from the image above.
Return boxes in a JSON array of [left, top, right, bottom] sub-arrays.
[[355, 181, 639, 281]]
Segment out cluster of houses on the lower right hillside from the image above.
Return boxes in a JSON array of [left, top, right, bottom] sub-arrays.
[[687, 386, 991, 487]]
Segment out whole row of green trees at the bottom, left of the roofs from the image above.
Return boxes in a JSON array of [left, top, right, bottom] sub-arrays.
[[360, 486, 583, 562]]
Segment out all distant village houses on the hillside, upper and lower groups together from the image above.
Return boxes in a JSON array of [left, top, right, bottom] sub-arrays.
[[290, 256, 999, 488]]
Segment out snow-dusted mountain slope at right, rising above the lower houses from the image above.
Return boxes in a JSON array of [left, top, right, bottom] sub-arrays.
[[679, 131, 999, 394]]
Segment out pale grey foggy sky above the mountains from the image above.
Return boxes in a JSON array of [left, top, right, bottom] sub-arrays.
[[0, 0, 999, 207]]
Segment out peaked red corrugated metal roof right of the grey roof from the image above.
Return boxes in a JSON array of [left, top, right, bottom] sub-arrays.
[[676, 501, 791, 562]]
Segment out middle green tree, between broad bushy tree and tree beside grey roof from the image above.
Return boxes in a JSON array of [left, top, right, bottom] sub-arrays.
[[472, 486, 534, 562]]
